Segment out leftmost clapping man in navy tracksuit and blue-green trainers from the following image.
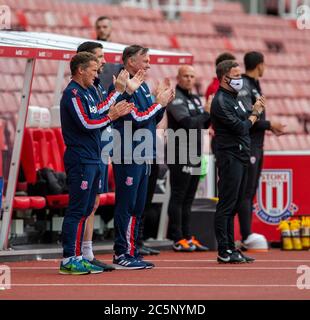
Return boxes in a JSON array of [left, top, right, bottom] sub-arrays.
[[59, 52, 132, 274]]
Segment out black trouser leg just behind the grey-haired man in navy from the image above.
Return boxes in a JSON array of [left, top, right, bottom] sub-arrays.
[[137, 163, 159, 247]]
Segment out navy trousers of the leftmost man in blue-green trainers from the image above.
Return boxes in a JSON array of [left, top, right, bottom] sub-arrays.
[[62, 152, 102, 258]]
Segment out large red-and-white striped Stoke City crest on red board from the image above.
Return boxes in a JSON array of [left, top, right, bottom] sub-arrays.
[[254, 169, 298, 225]]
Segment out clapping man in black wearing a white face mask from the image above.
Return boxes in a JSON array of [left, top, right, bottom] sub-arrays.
[[211, 60, 265, 263]]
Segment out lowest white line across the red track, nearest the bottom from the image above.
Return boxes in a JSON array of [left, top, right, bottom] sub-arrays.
[[6, 283, 297, 289]]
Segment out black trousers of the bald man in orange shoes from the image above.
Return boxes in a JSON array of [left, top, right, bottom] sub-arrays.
[[168, 164, 200, 242]]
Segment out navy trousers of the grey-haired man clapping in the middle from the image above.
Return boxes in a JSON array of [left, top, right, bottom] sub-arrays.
[[113, 163, 151, 256]]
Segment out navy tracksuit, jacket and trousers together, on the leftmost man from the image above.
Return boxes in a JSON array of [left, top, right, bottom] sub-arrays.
[[60, 80, 120, 258]]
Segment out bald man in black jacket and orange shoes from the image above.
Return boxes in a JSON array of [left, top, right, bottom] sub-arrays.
[[167, 66, 210, 252]]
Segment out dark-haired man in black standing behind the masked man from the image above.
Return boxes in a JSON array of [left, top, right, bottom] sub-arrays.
[[238, 51, 285, 249]]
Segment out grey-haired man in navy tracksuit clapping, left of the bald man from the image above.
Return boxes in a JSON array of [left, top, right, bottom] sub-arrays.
[[110, 45, 174, 269]]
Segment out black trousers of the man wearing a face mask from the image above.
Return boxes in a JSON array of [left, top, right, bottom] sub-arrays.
[[214, 152, 248, 253]]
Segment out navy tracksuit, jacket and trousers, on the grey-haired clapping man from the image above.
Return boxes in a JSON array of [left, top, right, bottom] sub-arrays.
[[109, 83, 165, 256]]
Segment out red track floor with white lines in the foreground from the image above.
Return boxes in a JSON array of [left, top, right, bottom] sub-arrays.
[[0, 249, 310, 300]]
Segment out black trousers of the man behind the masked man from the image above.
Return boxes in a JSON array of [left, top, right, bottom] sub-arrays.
[[238, 147, 264, 240]]
